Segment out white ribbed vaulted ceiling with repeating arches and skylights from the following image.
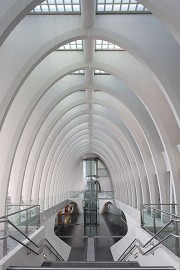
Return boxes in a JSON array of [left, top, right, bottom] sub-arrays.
[[0, 0, 180, 214]]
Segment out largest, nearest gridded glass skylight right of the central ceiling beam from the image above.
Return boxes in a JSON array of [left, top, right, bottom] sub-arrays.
[[97, 0, 149, 13]]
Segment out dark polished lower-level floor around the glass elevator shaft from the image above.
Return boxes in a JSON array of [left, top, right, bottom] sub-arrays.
[[55, 213, 127, 261]]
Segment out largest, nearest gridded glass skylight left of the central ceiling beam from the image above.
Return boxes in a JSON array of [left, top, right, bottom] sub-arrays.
[[30, 0, 81, 14]]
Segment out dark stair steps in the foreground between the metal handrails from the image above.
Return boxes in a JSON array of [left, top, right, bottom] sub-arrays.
[[8, 261, 175, 270]]
